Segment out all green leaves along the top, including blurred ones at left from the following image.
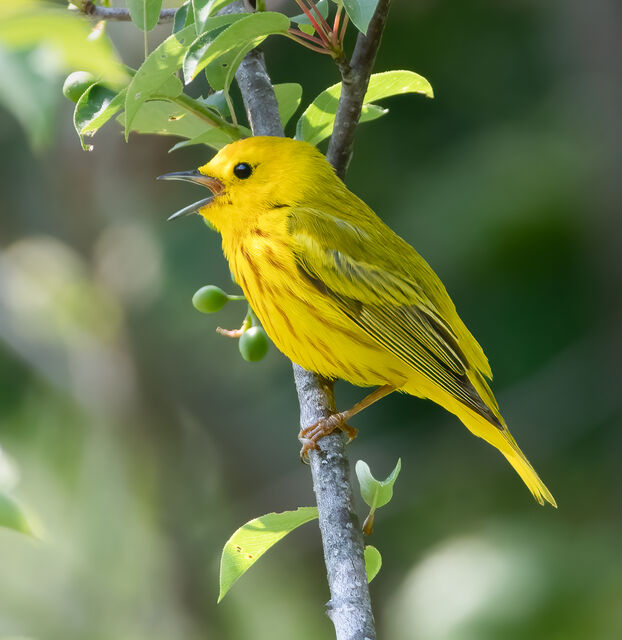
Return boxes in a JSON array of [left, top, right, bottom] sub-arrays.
[[0, 0, 433, 150]]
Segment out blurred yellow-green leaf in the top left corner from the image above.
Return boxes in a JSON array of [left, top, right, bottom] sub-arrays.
[[0, 0, 128, 87]]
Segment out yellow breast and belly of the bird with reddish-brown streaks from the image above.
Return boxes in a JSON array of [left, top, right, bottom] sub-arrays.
[[223, 214, 406, 386]]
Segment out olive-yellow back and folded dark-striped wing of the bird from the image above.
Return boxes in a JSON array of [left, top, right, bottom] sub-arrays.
[[288, 207, 500, 426]]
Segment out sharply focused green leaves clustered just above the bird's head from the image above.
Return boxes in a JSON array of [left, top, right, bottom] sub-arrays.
[[74, 1, 433, 149]]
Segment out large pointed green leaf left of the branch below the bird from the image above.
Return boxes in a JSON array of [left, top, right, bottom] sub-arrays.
[[218, 507, 317, 602]]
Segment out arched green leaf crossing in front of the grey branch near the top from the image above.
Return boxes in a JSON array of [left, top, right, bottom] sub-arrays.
[[183, 11, 289, 84]]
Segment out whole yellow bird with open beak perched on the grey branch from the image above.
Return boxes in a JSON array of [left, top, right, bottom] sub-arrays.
[[160, 136, 557, 507]]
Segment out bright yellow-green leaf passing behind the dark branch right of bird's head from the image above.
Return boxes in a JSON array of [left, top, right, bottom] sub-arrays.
[[296, 71, 434, 145]]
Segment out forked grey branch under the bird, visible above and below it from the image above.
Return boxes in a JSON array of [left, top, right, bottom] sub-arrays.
[[232, 0, 389, 640]]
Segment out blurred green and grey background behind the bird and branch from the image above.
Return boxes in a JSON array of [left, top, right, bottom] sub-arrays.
[[0, 0, 622, 640]]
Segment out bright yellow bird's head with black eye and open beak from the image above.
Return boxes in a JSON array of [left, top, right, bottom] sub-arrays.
[[159, 136, 338, 233]]
